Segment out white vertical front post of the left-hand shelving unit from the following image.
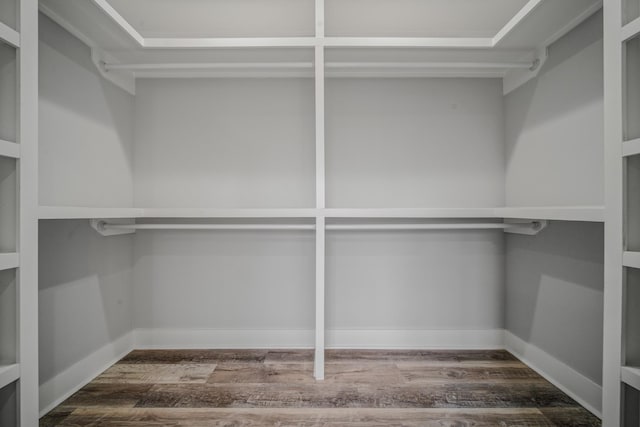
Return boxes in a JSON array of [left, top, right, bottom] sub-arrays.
[[17, 0, 39, 426]]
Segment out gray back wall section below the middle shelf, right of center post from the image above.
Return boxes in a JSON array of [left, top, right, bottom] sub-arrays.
[[326, 231, 504, 330]]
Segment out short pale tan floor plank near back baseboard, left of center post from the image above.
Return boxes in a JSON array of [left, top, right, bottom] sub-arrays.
[[93, 363, 216, 384]]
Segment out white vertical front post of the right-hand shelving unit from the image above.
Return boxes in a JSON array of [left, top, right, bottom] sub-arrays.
[[602, 0, 624, 426]]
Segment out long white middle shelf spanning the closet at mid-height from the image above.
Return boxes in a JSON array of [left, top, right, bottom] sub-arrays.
[[39, 206, 604, 222]]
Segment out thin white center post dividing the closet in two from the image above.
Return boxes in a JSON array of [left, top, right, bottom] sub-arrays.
[[313, 0, 325, 380]]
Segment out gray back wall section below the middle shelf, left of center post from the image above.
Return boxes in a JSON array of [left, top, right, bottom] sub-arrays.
[[134, 231, 315, 330]]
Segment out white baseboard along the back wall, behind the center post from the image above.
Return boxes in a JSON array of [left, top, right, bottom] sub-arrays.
[[134, 329, 503, 349]]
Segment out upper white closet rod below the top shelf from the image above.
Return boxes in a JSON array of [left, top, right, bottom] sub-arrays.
[[102, 60, 538, 71]]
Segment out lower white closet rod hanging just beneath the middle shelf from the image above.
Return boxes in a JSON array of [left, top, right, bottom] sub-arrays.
[[100, 221, 540, 231]]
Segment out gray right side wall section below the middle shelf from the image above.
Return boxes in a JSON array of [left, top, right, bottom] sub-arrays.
[[505, 221, 604, 384]]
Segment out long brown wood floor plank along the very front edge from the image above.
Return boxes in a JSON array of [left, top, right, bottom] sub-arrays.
[[50, 408, 554, 427]]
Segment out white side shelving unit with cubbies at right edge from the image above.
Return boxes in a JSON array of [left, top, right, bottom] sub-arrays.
[[603, 0, 640, 426]]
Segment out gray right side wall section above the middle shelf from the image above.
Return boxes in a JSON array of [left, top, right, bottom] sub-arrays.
[[504, 13, 604, 206]]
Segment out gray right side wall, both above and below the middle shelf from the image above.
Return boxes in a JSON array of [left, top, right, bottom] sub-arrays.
[[505, 13, 604, 384]]
